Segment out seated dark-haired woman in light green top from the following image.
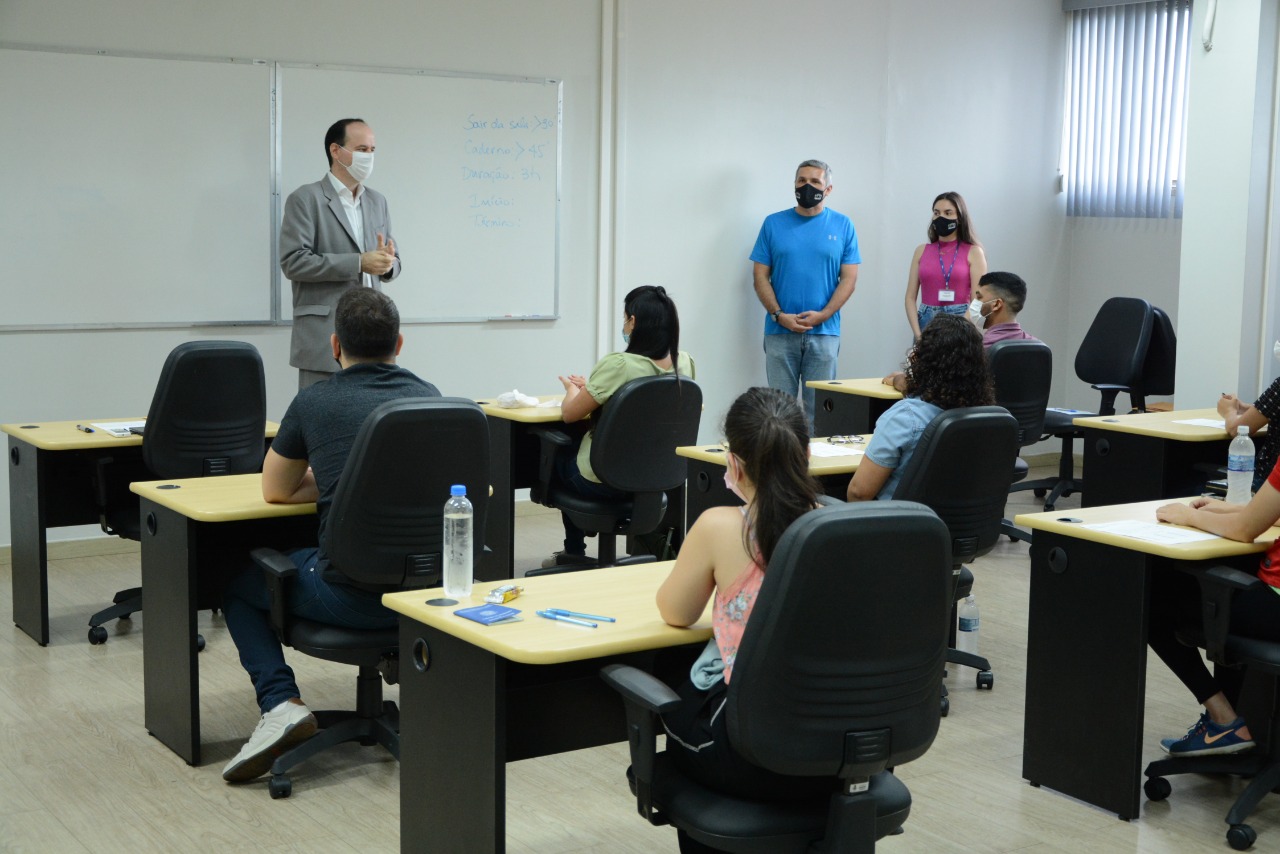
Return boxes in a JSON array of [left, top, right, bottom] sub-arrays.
[[543, 284, 694, 566]]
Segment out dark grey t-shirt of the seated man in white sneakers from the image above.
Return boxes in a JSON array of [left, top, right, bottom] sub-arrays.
[[271, 362, 440, 584]]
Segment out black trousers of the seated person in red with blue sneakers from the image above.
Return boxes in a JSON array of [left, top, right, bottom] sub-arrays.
[[1147, 571, 1280, 705]]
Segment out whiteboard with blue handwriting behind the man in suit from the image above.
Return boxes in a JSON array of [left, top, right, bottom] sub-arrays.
[[276, 64, 561, 323]]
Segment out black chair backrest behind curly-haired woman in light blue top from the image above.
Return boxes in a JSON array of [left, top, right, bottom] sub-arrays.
[[893, 406, 1020, 566]]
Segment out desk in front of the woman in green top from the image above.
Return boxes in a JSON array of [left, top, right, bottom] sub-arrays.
[[475, 394, 564, 581]]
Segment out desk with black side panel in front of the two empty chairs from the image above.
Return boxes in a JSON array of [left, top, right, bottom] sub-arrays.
[[1071, 408, 1230, 507]]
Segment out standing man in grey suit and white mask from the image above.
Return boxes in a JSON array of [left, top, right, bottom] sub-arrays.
[[280, 119, 401, 391]]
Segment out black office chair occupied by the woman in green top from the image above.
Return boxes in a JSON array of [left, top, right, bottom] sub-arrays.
[[526, 374, 703, 575]]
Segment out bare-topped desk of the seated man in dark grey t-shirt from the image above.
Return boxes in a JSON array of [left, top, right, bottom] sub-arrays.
[[129, 475, 317, 764]]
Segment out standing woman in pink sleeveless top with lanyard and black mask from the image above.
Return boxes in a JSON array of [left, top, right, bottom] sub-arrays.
[[906, 192, 987, 338]]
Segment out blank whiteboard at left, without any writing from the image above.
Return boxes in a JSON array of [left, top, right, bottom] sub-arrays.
[[0, 47, 274, 329]]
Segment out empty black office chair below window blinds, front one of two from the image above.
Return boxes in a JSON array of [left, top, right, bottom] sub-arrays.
[[1011, 297, 1167, 511]]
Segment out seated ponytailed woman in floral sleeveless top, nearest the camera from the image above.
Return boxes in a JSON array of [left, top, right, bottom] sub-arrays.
[[658, 388, 835, 800]]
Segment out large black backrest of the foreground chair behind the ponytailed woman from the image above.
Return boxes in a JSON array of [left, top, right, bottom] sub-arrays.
[[726, 501, 951, 777]]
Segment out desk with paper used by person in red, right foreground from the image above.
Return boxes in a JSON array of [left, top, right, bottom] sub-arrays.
[[1014, 499, 1280, 819]]
